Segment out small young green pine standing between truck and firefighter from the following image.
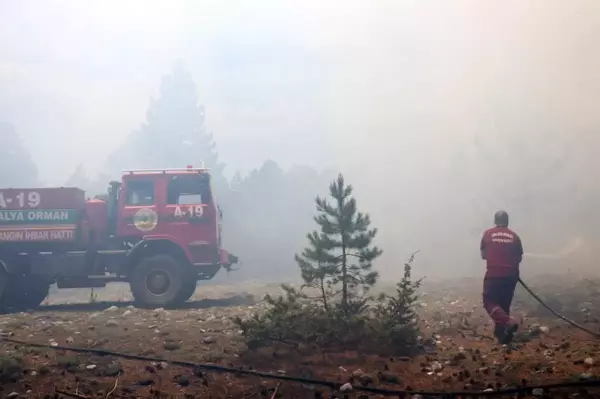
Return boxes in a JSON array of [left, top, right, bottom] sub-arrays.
[[297, 174, 382, 315]]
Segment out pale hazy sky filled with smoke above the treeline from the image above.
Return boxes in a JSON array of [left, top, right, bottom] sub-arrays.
[[0, 0, 600, 276]]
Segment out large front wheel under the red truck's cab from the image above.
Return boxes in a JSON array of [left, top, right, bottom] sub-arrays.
[[130, 255, 189, 308]]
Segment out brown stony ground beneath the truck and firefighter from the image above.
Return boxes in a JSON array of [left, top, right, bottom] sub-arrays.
[[0, 275, 600, 398]]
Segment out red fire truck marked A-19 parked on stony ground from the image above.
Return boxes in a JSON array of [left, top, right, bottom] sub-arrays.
[[0, 167, 238, 310]]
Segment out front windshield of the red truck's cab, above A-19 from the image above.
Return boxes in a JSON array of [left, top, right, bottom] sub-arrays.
[[167, 175, 211, 205]]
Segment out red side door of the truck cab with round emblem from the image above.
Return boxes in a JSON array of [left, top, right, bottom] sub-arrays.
[[118, 177, 158, 237]]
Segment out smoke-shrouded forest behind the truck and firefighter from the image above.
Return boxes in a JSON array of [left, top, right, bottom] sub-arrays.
[[0, 63, 600, 280]]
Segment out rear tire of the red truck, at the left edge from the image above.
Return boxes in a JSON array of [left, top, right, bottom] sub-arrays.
[[1, 275, 50, 312]]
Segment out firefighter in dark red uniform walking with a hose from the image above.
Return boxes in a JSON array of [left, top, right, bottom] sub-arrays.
[[480, 211, 523, 344]]
